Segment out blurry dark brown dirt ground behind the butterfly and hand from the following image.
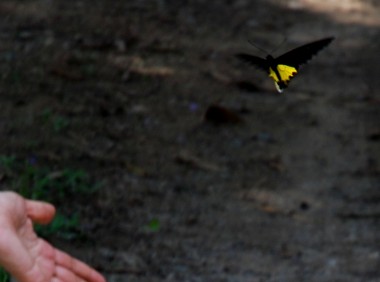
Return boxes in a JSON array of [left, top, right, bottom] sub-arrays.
[[0, 0, 380, 282]]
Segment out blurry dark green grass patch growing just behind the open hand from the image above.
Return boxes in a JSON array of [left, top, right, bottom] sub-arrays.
[[0, 156, 100, 240]]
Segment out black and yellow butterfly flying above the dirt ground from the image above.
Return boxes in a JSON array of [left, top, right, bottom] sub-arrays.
[[236, 37, 334, 92]]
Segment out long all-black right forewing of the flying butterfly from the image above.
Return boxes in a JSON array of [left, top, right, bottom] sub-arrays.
[[276, 37, 334, 69]]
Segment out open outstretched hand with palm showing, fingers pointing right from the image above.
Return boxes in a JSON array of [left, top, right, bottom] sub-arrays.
[[0, 192, 106, 282]]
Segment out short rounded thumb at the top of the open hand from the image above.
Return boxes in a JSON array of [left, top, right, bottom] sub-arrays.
[[25, 200, 55, 224]]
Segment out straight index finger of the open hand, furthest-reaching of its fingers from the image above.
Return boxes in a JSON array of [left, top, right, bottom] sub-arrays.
[[55, 250, 106, 282]]
